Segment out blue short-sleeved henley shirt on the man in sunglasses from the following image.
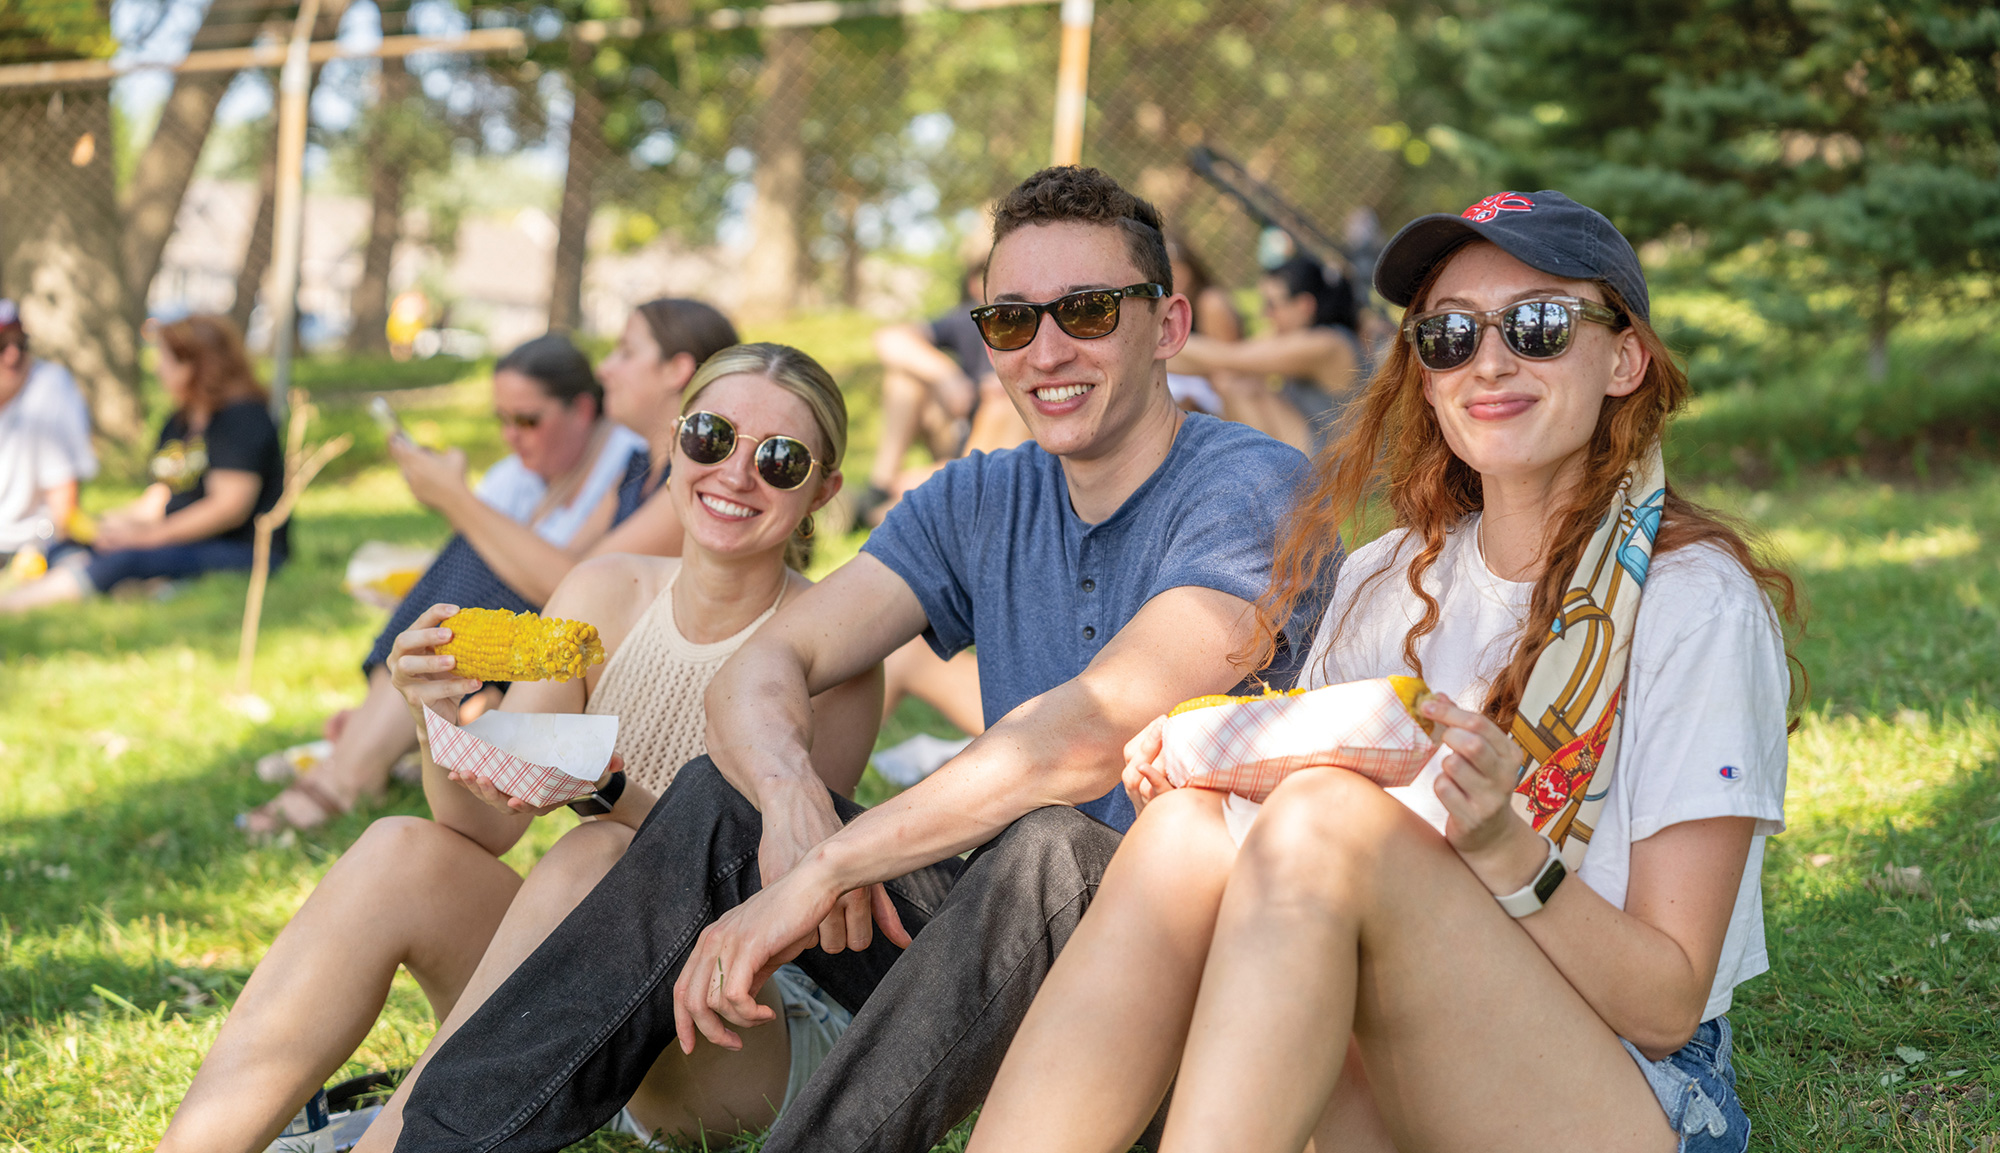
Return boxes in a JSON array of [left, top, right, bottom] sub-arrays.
[[862, 412, 1338, 831]]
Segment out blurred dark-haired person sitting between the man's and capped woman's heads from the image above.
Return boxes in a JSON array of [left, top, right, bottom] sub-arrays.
[[1168, 256, 1360, 452]]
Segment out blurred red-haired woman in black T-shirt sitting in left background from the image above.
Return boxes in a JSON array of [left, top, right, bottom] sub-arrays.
[[0, 314, 290, 613]]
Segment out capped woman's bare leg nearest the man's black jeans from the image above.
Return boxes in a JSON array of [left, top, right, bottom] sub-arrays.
[[968, 789, 1236, 1153]]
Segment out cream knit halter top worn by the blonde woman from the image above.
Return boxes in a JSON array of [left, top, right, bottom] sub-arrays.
[[584, 564, 790, 793]]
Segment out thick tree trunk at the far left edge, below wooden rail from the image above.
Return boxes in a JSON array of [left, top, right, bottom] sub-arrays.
[[0, 88, 146, 448]]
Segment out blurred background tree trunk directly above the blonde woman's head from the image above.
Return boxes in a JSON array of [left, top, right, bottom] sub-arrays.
[[742, 28, 812, 318]]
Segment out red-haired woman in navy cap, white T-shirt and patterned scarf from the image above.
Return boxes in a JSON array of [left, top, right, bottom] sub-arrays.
[[972, 192, 1792, 1153]]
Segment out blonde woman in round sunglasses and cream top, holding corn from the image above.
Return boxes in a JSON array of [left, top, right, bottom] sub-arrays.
[[160, 344, 882, 1153]]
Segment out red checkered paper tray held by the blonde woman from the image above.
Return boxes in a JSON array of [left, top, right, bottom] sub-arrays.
[[424, 709, 618, 807]]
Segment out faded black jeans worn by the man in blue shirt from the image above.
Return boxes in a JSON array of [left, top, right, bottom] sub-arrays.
[[396, 757, 1118, 1153]]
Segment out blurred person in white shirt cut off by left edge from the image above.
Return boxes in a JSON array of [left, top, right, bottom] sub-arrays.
[[0, 300, 98, 574]]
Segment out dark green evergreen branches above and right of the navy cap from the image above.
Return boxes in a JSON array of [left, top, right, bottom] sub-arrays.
[[1428, 0, 2000, 354]]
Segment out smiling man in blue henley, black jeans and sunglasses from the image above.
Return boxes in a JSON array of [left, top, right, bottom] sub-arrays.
[[376, 168, 1332, 1153]]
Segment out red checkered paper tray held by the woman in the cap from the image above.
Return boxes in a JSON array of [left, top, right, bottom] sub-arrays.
[[1160, 677, 1438, 801]]
